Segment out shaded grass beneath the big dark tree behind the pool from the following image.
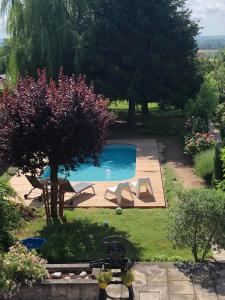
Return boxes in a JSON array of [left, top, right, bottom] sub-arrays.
[[110, 101, 185, 139]]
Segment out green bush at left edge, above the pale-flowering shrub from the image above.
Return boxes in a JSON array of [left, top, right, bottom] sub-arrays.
[[0, 182, 21, 251]]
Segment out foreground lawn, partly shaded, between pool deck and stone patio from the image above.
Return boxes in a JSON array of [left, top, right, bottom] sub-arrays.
[[18, 166, 192, 263]]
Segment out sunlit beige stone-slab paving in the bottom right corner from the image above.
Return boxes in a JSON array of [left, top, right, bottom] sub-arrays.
[[107, 263, 225, 300]]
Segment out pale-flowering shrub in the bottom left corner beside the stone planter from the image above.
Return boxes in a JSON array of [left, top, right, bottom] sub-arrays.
[[0, 243, 48, 295]]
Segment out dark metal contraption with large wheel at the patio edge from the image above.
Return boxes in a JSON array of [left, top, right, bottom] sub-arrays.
[[90, 235, 136, 300]]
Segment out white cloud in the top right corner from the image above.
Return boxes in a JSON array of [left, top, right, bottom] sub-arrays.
[[187, 0, 225, 19]]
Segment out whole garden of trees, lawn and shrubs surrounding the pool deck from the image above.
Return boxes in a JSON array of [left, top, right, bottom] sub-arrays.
[[0, 1, 225, 298]]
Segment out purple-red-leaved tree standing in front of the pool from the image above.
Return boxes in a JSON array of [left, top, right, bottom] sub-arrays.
[[0, 70, 112, 219]]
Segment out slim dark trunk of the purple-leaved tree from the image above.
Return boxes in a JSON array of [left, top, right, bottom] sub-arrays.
[[50, 164, 58, 220]]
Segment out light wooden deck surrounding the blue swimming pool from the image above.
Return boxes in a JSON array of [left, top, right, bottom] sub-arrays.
[[10, 139, 166, 208]]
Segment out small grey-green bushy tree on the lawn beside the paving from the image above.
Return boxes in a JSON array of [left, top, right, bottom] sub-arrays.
[[169, 188, 225, 261]]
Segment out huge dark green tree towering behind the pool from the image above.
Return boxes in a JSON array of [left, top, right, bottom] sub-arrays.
[[83, 0, 199, 124]]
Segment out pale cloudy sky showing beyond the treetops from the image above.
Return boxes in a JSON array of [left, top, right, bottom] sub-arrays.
[[0, 0, 225, 38]]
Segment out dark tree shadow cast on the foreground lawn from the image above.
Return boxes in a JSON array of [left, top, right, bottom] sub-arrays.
[[40, 219, 142, 263]]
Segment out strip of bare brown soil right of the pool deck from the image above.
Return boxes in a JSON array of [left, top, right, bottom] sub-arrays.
[[159, 137, 204, 188]]
